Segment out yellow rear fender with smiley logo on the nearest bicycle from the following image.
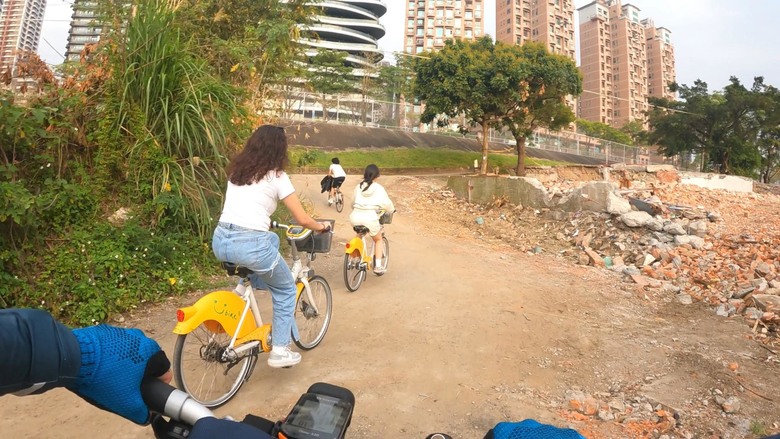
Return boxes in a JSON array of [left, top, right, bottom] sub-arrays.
[[173, 291, 257, 338]]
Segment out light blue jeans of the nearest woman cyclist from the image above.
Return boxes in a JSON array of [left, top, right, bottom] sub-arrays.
[[211, 223, 298, 346]]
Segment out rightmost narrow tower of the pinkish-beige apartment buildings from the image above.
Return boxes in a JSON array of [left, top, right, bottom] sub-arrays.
[[642, 19, 677, 99]]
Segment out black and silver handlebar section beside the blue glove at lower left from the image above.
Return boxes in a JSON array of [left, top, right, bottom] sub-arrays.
[[141, 378, 215, 425]]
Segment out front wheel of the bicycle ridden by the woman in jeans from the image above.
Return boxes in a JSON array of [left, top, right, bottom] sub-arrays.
[[295, 276, 333, 351]]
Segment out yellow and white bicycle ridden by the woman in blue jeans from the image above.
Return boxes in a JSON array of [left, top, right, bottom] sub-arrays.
[[173, 220, 333, 408]]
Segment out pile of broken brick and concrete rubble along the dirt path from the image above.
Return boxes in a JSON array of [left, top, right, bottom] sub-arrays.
[[431, 170, 780, 337]]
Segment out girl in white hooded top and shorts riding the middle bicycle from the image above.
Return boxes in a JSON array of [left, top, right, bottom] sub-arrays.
[[349, 164, 395, 273]]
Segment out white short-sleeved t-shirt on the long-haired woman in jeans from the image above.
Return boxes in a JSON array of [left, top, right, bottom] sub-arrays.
[[219, 171, 295, 231]]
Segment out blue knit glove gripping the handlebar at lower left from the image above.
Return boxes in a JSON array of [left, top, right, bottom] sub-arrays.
[[70, 325, 170, 425]]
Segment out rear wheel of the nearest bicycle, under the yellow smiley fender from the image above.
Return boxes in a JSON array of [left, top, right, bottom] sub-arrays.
[[173, 322, 258, 408]]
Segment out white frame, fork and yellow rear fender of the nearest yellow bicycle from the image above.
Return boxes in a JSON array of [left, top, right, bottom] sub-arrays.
[[173, 232, 318, 355]]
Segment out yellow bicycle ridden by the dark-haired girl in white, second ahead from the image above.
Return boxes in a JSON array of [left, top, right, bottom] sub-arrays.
[[344, 211, 394, 292]]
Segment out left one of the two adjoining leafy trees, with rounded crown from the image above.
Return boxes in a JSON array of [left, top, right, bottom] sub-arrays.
[[412, 36, 524, 174]]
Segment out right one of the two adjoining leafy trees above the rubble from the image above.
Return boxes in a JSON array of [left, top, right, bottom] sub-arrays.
[[501, 42, 582, 175]]
